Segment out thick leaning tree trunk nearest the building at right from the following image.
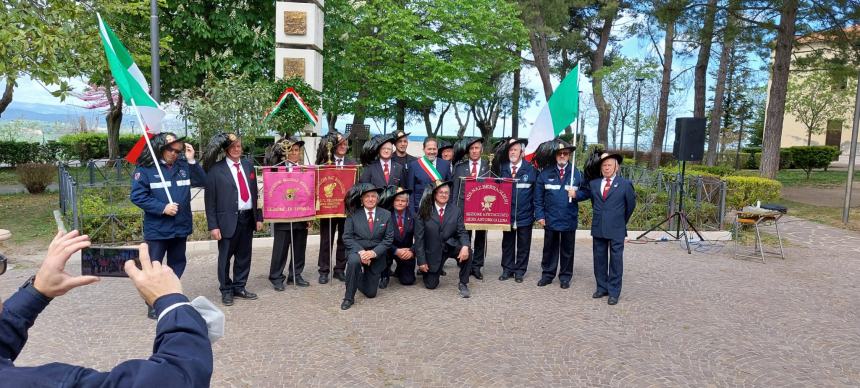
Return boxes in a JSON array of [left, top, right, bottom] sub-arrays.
[[761, 0, 798, 179]]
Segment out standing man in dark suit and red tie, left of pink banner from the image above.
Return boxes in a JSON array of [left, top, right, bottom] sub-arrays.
[[205, 133, 263, 306]]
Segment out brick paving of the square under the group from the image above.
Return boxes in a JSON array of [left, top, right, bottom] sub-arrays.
[[0, 229, 860, 387]]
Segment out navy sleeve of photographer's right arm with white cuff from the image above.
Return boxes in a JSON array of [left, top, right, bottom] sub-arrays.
[[74, 294, 213, 388]]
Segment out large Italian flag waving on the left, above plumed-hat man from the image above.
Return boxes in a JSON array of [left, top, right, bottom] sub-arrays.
[[96, 14, 165, 163]]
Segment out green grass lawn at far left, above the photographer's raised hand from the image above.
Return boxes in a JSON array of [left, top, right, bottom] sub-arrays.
[[0, 193, 59, 246]]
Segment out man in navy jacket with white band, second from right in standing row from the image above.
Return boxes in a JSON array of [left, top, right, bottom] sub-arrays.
[[535, 139, 588, 289]]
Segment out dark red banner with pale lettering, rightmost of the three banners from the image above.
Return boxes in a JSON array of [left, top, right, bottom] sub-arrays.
[[463, 178, 514, 231]]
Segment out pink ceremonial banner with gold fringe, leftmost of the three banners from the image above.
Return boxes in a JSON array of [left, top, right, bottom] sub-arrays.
[[263, 166, 316, 222]]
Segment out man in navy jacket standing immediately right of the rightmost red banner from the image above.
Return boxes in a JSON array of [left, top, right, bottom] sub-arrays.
[[499, 139, 537, 283]]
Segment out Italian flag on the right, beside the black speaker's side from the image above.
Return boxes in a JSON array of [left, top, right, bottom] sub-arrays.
[[525, 65, 579, 160]]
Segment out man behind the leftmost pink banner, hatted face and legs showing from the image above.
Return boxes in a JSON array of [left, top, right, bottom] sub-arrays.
[[267, 138, 310, 291]]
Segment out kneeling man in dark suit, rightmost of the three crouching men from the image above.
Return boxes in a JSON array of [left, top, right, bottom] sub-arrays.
[[413, 181, 472, 298]]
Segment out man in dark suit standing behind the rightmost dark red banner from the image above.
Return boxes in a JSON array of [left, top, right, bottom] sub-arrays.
[[454, 137, 490, 280]]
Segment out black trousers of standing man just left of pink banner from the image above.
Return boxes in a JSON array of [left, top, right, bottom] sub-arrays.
[[218, 211, 257, 294]]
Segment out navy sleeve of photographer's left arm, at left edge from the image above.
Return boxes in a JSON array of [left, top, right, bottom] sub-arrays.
[[0, 287, 50, 361]]
